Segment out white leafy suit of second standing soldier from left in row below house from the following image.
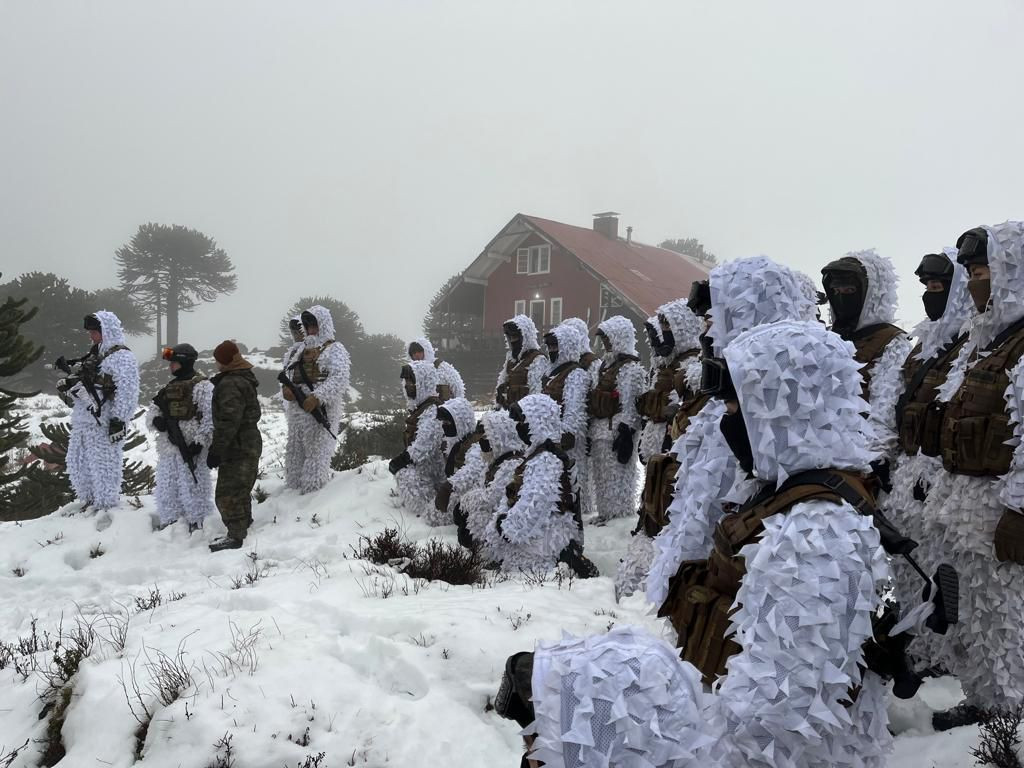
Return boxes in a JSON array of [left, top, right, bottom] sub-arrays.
[[542, 325, 590, 494]]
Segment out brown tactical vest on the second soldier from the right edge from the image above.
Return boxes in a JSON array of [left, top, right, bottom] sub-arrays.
[[896, 334, 968, 456]]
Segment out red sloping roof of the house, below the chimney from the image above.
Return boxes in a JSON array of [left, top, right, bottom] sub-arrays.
[[523, 215, 710, 315]]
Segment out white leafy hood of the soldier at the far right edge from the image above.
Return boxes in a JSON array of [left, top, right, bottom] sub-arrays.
[[962, 221, 1024, 349]]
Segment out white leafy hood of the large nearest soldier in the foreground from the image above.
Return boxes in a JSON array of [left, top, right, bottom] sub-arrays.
[[725, 322, 877, 484]]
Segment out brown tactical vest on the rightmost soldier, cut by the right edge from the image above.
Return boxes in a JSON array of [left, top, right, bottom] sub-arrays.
[[933, 329, 1024, 476]]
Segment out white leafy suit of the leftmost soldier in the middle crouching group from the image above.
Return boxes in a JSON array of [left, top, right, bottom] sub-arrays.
[[394, 360, 444, 517]]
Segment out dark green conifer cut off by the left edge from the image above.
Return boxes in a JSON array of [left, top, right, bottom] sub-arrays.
[[0, 282, 43, 511]]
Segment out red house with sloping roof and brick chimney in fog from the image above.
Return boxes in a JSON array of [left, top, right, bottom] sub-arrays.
[[431, 213, 711, 396]]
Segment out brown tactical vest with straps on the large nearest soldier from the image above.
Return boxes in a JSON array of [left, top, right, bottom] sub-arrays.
[[657, 470, 873, 685]]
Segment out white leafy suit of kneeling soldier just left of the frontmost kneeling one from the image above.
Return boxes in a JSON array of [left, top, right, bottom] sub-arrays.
[[462, 411, 526, 560]]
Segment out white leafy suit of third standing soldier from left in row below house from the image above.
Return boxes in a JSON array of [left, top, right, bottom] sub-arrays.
[[590, 315, 644, 520]]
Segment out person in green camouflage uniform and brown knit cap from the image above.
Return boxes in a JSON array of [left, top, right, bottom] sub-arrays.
[[206, 341, 263, 552]]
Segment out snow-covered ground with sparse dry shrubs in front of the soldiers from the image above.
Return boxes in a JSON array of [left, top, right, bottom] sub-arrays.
[[0, 400, 977, 768]]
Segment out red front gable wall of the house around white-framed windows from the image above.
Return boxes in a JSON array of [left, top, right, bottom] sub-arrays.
[[483, 233, 601, 334]]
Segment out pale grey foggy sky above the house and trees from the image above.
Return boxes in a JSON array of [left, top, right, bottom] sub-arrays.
[[0, 0, 1024, 347]]
